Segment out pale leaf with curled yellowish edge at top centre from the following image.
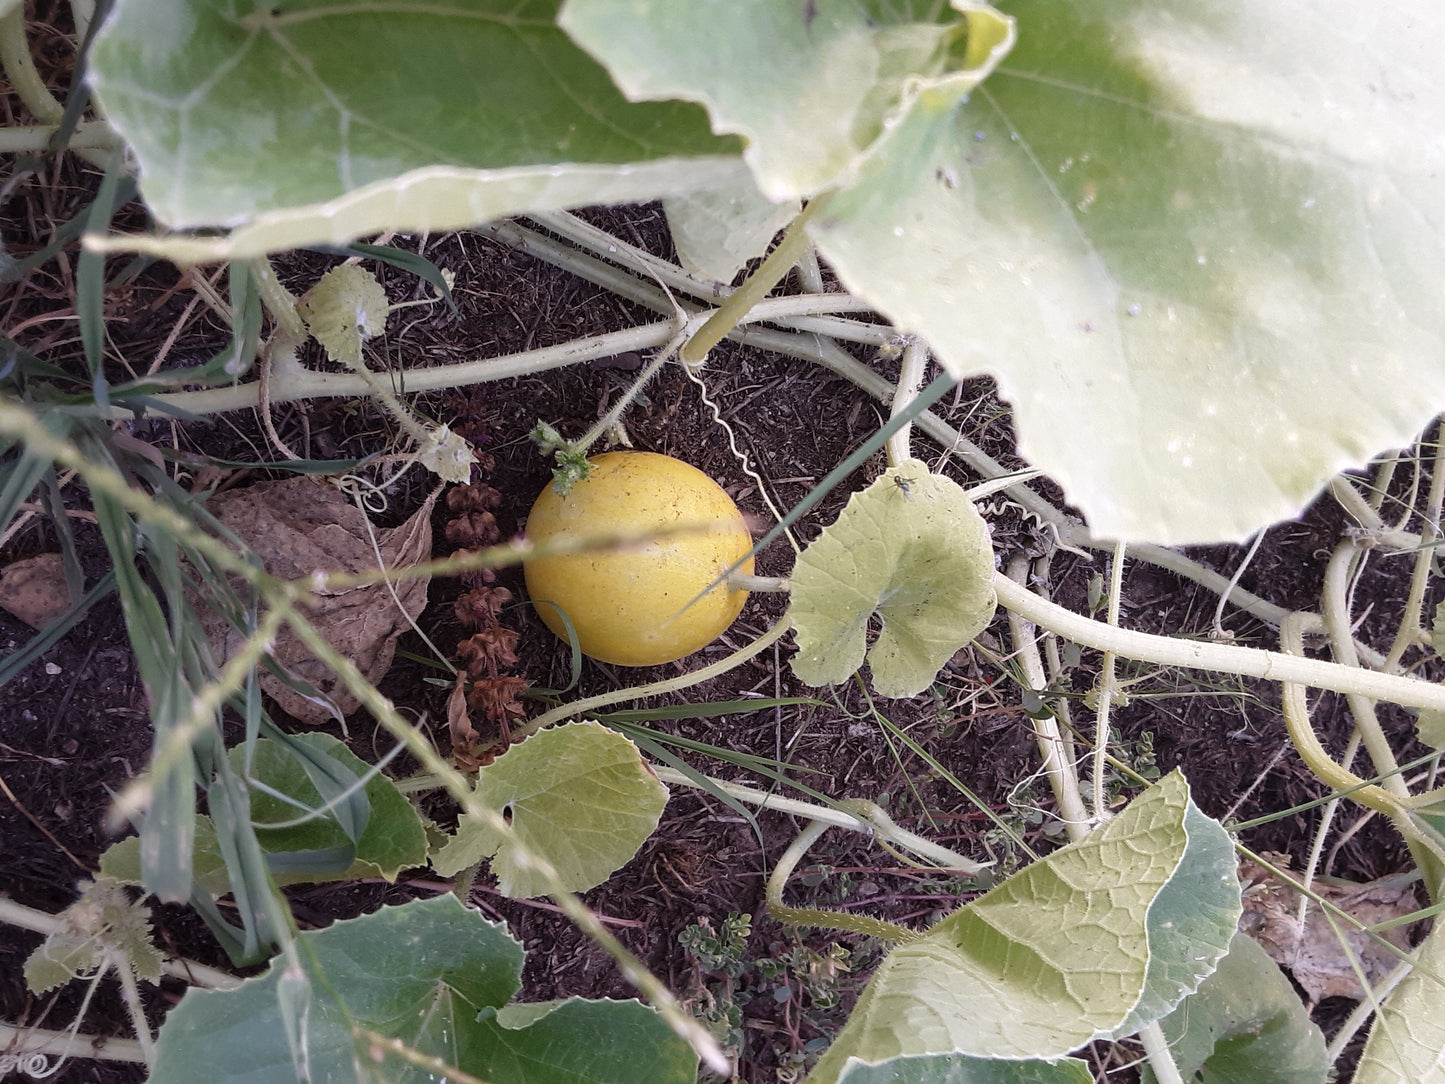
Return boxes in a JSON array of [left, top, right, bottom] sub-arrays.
[[558, 0, 1012, 202]]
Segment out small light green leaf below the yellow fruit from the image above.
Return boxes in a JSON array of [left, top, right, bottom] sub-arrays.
[[432, 723, 668, 896]]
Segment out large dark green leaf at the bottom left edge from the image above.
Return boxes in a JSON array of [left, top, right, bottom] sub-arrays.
[[150, 895, 696, 1084]]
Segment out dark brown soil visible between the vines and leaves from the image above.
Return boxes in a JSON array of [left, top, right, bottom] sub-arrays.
[[0, 12, 1439, 1083]]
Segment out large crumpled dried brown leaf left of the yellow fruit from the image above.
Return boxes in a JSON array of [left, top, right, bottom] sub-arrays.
[[195, 477, 436, 726]]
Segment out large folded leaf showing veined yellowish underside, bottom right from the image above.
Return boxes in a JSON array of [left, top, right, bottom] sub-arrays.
[[809, 772, 1238, 1084]]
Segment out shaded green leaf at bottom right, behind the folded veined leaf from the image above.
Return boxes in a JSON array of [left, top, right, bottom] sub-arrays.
[[1143, 934, 1329, 1084]]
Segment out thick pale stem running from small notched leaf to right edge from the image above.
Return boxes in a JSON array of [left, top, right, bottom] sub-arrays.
[[994, 574, 1445, 711]]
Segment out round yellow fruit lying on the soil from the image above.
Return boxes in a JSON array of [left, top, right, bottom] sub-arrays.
[[522, 451, 753, 666]]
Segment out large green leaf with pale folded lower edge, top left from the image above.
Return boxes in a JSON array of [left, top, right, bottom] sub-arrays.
[[90, 0, 741, 259]]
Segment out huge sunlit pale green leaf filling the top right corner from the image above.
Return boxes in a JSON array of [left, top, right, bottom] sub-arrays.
[[811, 0, 1445, 542]]
